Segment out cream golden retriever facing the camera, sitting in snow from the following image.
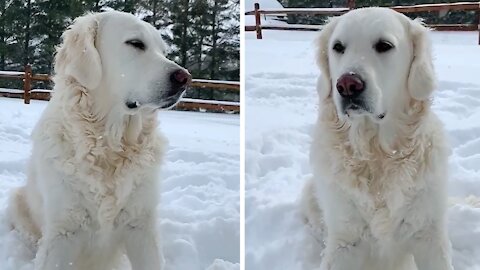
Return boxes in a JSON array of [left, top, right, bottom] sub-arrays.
[[302, 8, 452, 270]]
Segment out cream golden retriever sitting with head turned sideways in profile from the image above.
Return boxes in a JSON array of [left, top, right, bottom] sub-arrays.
[[9, 11, 191, 270]]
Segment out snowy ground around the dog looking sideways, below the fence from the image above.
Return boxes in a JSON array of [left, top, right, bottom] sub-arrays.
[[0, 98, 240, 270]]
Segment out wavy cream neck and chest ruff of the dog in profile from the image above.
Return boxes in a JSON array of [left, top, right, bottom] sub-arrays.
[[33, 75, 164, 227]]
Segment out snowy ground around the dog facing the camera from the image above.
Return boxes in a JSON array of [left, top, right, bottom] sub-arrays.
[[244, 31, 480, 270]]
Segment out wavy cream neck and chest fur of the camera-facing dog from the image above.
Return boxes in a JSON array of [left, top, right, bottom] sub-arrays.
[[312, 104, 434, 239]]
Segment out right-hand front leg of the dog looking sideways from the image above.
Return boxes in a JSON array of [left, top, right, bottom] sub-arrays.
[[125, 219, 163, 270]]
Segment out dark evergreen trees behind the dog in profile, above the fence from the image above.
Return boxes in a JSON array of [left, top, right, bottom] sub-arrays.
[[0, 0, 240, 100]]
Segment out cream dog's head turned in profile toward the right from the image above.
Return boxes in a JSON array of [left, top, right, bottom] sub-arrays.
[[55, 11, 191, 113]]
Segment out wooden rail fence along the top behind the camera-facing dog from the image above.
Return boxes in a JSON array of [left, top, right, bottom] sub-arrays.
[[245, 0, 480, 44]]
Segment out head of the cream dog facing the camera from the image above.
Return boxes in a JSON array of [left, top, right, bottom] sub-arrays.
[[317, 8, 435, 121]]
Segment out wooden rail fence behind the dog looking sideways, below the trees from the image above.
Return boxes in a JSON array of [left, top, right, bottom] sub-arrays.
[[0, 65, 240, 113]]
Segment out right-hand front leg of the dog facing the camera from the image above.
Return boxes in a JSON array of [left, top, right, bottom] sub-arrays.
[[412, 226, 453, 270]]
